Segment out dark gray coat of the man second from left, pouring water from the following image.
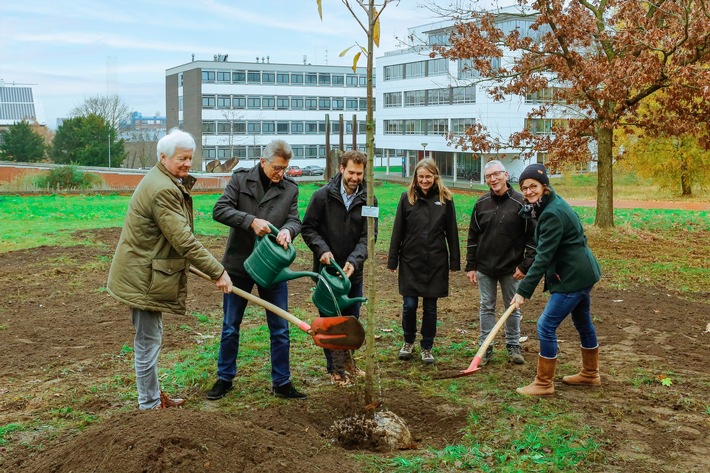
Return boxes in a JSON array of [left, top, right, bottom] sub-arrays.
[[212, 163, 301, 277]]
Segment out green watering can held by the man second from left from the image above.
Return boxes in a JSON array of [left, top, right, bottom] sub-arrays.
[[244, 225, 318, 288]]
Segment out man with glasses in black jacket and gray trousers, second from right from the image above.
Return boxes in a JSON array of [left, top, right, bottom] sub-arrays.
[[466, 160, 535, 364]]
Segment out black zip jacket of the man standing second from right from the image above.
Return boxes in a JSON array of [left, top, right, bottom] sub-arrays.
[[466, 186, 535, 277]]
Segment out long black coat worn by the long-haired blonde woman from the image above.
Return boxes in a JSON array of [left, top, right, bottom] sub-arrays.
[[387, 186, 461, 297]]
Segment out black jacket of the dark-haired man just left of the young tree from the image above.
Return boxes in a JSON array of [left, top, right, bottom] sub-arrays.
[[301, 173, 377, 282]]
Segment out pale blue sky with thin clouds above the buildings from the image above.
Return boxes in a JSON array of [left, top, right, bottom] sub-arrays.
[[0, 0, 512, 129]]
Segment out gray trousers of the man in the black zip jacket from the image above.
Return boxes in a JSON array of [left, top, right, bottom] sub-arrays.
[[476, 271, 520, 346]]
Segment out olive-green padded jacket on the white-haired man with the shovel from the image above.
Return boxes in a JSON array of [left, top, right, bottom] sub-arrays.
[[107, 163, 224, 314]]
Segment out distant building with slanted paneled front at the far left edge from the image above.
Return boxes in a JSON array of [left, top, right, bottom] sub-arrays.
[[0, 80, 47, 144]]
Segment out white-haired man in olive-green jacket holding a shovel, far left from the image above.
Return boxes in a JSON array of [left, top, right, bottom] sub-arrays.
[[107, 129, 232, 409]]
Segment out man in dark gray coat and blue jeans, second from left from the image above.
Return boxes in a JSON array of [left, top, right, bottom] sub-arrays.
[[207, 140, 306, 401]]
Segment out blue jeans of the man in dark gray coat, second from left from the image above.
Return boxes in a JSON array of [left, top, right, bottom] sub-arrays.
[[217, 274, 291, 387]]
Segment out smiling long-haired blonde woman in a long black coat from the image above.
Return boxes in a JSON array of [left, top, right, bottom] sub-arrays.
[[387, 159, 461, 363]]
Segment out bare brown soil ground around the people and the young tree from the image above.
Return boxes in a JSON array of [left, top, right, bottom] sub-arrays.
[[0, 229, 710, 473]]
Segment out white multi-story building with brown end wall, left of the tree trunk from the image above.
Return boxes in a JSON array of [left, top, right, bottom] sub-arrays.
[[165, 55, 367, 169]]
